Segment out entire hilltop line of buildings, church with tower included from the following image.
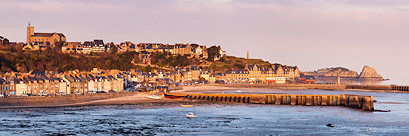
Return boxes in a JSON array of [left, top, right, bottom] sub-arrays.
[[22, 23, 222, 59]]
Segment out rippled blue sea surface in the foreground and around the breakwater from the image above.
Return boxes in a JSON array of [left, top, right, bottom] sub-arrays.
[[0, 89, 409, 135]]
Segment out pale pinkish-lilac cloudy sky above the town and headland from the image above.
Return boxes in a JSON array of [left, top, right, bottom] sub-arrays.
[[0, 0, 409, 84]]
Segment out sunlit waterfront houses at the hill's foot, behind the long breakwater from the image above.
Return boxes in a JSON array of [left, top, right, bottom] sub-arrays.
[[124, 64, 300, 84]]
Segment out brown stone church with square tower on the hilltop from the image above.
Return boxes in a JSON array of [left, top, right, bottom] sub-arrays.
[[27, 23, 67, 46]]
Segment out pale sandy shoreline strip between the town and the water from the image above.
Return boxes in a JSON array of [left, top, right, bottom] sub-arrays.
[[0, 85, 409, 109]]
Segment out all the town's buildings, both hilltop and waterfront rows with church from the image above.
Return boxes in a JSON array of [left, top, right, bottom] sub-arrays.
[[0, 23, 315, 97]]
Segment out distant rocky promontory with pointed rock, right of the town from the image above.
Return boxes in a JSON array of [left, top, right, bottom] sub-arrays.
[[303, 66, 385, 81]]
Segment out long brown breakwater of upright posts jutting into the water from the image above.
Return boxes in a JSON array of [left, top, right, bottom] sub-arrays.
[[186, 94, 374, 111]]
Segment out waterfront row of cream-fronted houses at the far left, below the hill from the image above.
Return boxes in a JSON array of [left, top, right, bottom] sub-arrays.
[[0, 71, 124, 96]]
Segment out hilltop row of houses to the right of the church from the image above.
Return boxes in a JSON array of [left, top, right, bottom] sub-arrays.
[[62, 39, 214, 58]]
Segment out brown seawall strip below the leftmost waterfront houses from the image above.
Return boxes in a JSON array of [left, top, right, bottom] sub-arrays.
[[0, 93, 135, 108]]
